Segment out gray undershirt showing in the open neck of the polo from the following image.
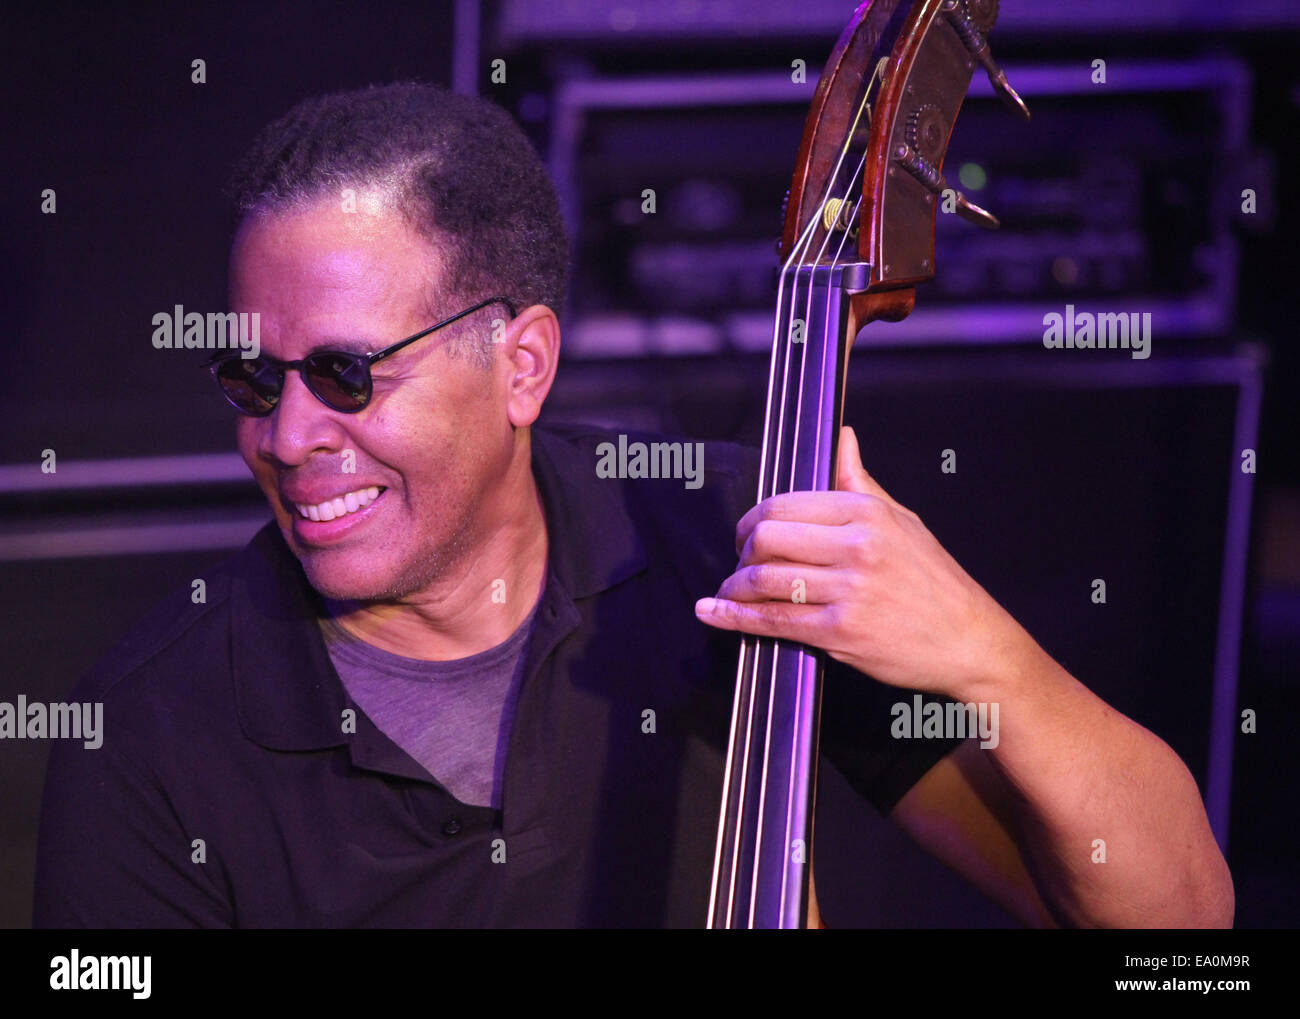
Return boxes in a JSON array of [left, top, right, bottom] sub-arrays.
[[320, 606, 537, 808]]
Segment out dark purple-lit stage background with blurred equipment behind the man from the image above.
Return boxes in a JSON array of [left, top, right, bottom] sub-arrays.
[[0, 0, 1300, 927]]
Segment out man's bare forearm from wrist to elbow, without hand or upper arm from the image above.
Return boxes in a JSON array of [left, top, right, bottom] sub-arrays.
[[979, 630, 1234, 928]]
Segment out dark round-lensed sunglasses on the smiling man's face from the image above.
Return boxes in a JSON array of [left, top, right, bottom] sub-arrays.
[[204, 298, 515, 417]]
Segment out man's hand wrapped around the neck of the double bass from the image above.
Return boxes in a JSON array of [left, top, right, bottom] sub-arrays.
[[696, 428, 1032, 701]]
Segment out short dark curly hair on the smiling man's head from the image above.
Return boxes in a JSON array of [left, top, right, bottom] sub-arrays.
[[230, 82, 568, 364]]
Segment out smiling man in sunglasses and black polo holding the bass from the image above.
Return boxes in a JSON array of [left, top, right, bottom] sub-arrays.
[[35, 86, 1231, 927]]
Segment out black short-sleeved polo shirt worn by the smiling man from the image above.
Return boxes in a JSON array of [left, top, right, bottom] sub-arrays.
[[35, 428, 954, 927]]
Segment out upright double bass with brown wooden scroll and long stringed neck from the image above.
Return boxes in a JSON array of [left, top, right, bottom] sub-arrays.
[[707, 0, 1028, 928]]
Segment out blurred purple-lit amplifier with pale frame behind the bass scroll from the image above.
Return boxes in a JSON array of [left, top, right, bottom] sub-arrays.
[[550, 57, 1266, 356]]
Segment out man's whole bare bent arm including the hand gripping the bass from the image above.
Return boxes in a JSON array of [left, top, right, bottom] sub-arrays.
[[696, 428, 1234, 927]]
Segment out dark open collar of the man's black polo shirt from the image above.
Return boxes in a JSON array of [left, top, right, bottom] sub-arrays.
[[230, 428, 646, 750]]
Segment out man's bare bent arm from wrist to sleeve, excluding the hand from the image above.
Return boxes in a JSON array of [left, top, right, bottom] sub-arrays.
[[891, 645, 1234, 928]]
